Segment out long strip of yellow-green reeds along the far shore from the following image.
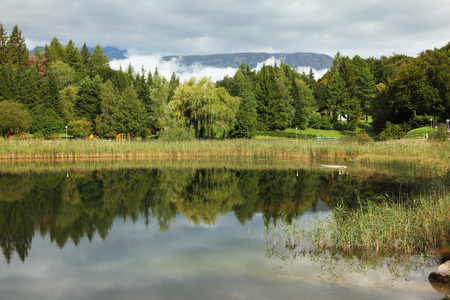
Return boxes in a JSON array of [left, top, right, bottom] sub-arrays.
[[0, 139, 450, 172]]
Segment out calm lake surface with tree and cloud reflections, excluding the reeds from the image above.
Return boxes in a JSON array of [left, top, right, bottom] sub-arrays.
[[0, 164, 448, 300]]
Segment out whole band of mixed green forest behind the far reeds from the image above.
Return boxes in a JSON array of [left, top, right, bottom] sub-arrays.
[[0, 23, 450, 140]]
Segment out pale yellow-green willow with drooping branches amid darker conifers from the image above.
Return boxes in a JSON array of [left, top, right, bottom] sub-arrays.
[[170, 77, 240, 138]]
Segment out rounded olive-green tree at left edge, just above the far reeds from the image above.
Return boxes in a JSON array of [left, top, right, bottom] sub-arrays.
[[0, 100, 30, 137]]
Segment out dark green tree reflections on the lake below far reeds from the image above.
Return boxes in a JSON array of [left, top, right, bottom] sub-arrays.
[[0, 167, 444, 263]]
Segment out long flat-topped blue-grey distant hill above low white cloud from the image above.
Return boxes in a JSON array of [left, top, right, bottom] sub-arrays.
[[163, 52, 333, 70]]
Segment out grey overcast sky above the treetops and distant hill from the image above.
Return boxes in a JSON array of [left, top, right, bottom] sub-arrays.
[[0, 0, 450, 57]]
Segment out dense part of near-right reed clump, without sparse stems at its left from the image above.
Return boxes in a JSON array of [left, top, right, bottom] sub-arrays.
[[313, 195, 450, 254]]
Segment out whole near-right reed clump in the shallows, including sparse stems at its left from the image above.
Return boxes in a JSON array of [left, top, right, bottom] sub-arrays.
[[268, 195, 450, 257]]
